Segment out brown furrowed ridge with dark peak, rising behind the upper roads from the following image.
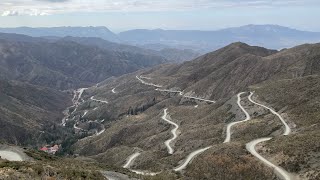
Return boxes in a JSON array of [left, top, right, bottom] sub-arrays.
[[147, 43, 320, 99]]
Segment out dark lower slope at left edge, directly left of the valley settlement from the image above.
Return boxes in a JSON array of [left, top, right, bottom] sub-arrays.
[[0, 80, 71, 145]]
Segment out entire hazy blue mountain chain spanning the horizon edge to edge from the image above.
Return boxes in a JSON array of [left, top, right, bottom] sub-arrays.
[[0, 25, 320, 53]]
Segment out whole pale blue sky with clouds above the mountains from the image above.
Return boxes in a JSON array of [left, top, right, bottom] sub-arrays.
[[0, 0, 320, 32]]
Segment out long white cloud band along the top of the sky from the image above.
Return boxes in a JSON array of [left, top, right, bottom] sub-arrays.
[[0, 0, 320, 16]]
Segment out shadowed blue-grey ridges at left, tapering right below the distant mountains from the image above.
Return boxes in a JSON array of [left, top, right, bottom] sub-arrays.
[[0, 32, 167, 90]]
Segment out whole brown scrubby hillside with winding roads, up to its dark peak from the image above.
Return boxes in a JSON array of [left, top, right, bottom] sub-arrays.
[[65, 43, 320, 179]]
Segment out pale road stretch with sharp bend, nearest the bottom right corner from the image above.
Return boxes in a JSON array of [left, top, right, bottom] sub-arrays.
[[246, 137, 291, 180]]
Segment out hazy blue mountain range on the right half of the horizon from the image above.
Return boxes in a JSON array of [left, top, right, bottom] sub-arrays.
[[119, 25, 320, 52]]
